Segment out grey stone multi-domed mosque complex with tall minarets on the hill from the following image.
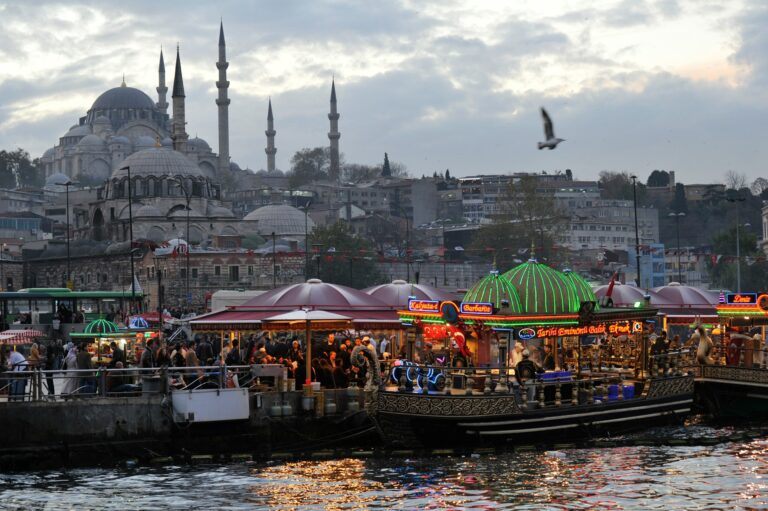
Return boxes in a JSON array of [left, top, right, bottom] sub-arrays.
[[36, 24, 339, 244]]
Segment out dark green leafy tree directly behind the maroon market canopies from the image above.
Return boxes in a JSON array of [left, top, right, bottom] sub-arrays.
[[312, 221, 381, 289]]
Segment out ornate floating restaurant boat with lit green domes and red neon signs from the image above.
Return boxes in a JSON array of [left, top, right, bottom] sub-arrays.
[[369, 260, 694, 448]]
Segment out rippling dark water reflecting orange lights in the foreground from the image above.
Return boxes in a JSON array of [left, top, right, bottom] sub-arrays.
[[0, 429, 768, 511]]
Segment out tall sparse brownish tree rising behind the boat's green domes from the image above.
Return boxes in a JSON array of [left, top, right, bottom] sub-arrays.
[[472, 176, 565, 269]]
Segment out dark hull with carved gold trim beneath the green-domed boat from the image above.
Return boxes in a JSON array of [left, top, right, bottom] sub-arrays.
[[374, 376, 693, 447]]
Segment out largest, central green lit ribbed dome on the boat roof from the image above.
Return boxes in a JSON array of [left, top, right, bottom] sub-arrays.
[[504, 259, 580, 314]]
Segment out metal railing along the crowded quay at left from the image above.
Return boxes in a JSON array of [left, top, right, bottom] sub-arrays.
[[0, 366, 274, 402]]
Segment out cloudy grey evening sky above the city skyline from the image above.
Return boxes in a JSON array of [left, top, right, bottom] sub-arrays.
[[0, 0, 768, 184]]
